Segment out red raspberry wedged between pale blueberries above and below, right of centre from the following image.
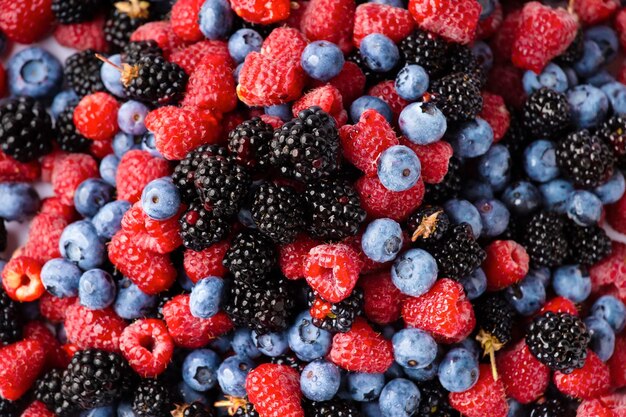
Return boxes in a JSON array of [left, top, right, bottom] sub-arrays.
[[354, 177, 425, 221]]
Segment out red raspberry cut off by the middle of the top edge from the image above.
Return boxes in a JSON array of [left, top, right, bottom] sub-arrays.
[[300, 0, 356, 53]]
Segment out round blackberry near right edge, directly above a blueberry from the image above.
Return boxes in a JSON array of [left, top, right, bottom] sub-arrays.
[[556, 130, 615, 188]]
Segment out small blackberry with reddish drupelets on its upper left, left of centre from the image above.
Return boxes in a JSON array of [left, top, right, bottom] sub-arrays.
[[179, 202, 230, 251]]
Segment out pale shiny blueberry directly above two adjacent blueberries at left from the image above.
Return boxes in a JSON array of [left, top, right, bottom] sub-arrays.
[[59, 220, 106, 270]]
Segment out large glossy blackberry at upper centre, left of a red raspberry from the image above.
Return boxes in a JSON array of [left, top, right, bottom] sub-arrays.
[[269, 106, 340, 181]]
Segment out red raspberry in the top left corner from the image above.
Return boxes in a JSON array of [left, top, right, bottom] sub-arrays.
[[0, 0, 54, 44]]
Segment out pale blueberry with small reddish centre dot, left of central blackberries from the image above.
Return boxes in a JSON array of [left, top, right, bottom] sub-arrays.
[[141, 177, 181, 220]]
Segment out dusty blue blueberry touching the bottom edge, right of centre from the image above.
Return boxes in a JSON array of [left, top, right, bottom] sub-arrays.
[[378, 378, 421, 417]]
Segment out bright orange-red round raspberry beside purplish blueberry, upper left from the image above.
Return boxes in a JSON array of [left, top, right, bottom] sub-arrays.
[[74, 92, 120, 140]]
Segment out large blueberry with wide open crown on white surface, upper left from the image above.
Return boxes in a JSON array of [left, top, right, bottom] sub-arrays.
[[7, 47, 63, 99]]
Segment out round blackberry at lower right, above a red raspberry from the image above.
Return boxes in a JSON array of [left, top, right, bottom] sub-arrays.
[[526, 311, 590, 374]]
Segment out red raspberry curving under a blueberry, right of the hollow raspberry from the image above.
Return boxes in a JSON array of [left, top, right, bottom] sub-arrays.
[[163, 294, 233, 349]]
